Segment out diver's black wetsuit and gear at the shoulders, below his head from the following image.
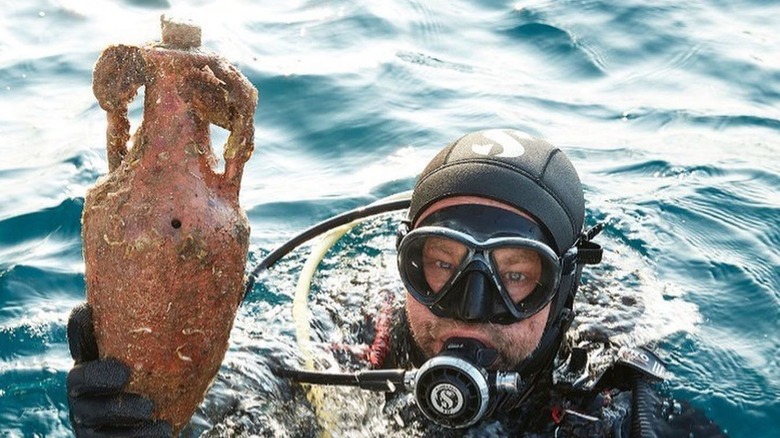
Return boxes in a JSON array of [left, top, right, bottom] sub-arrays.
[[383, 315, 725, 438]]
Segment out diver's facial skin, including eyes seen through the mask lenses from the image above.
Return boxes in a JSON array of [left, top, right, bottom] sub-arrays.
[[406, 196, 550, 369]]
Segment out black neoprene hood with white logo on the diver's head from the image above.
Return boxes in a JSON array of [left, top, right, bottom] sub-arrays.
[[409, 129, 585, 255]]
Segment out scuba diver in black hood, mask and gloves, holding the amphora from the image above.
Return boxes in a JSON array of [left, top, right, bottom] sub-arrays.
[[67, 129, 723, 438]]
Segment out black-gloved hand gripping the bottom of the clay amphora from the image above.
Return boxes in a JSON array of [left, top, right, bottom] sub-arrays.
[[68, 303, 173, 438]]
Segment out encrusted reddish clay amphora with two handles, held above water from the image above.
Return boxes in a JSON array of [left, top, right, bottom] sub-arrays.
[[82, 21, 257, 431]]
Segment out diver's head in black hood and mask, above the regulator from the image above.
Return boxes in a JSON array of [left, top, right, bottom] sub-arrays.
[[399, 130, 584, 369]]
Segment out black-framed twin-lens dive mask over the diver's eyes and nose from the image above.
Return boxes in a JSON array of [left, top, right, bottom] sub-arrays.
[[397, 204, 577, 324]]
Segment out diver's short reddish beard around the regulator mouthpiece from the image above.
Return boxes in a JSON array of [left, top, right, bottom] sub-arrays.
[[412, 319, 536, 370]]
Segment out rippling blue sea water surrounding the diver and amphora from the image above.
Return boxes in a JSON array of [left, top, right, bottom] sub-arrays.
[[0, 0, 780, 437]]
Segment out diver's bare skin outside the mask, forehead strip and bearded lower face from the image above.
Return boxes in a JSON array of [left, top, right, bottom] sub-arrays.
[[406, 196, 550, 369]]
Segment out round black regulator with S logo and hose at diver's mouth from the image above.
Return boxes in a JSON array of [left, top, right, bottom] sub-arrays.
[[276, 338, 523, 428]]
